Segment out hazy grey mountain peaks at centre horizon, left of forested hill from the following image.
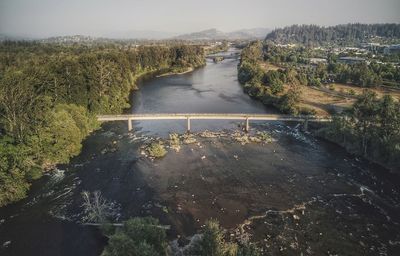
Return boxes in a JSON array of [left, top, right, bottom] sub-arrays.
[[174, 28, 271, 40]]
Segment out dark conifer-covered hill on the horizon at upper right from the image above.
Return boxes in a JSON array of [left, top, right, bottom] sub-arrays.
[[265, 23, 400, 45]]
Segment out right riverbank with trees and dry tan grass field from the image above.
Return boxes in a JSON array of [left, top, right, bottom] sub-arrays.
[[238, 43, 400, 172]]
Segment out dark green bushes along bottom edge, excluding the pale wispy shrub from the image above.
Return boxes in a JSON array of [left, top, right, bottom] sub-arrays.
[[102, 217, 261, 256]]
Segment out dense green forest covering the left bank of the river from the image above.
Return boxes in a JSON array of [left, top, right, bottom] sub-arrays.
[[0, 42, 205, 206]]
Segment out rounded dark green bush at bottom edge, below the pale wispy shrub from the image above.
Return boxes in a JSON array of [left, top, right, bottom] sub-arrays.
[[102, 217, 167, 256]]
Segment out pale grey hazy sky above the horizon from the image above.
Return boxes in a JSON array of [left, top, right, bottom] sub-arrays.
[[0, 0, 400, 37]]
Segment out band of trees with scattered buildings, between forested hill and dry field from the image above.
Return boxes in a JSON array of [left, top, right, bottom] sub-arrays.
[[263, 43, 400, 87]]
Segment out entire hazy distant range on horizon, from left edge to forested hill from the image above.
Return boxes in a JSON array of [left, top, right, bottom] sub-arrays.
[[0, 28, 271, 43]]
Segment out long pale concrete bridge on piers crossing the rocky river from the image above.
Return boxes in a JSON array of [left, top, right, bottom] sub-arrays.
[[97, 113, 332, 132]]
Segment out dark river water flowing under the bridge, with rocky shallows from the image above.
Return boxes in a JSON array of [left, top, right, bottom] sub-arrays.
[[0, 49, 400, 255]]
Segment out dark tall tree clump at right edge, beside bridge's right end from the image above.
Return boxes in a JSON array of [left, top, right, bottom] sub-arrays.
[[321, 91, 400, 167]]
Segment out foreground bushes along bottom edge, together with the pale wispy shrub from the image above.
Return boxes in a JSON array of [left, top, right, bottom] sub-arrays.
[[82, 191, 261, 256]]
